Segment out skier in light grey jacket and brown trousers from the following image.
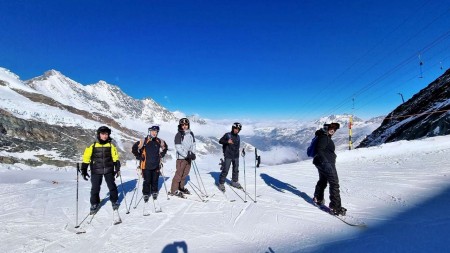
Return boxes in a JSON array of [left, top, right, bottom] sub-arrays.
[[170, 118, 196, 198]]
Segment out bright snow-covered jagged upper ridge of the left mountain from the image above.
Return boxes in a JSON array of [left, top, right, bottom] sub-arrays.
[[25, 70, 176, 122]]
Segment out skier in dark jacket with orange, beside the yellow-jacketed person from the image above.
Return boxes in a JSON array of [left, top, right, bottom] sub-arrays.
[[131, 126, 171, 202]]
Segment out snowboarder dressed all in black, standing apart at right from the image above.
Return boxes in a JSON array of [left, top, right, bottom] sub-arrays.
[[313, 123, 347, 215]]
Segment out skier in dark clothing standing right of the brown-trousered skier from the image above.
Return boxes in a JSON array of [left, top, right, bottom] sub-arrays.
[[219, 122, 242, 191]]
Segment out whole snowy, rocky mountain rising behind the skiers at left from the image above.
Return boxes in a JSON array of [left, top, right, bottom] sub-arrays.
[[0, 68, 183, 166]]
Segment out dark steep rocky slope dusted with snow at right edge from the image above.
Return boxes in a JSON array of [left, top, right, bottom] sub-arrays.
[[358, 69, 450, 148]]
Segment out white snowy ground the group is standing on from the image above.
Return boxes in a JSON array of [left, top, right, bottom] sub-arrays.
[[0, 136, 450, 252]]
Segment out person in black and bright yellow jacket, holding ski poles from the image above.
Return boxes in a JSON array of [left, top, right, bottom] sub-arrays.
[[81, 126, 120, 214]]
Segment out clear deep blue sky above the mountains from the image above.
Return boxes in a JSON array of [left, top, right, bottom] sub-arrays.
[[0, 0, 450, 120]]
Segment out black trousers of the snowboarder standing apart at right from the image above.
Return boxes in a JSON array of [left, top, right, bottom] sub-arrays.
[[314, 163, 341, 208]]
